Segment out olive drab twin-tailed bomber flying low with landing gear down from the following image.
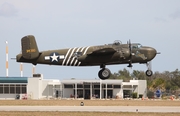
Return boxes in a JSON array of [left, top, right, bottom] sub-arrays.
[[16, 35, 157, 79]]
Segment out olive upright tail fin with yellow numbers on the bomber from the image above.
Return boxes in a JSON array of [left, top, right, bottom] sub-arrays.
[[21, 35, 39, 60]]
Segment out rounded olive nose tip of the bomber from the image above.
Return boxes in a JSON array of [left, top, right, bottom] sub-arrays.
[[146, 47, 157, 61]]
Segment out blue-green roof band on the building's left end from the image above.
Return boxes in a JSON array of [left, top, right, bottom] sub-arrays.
[[0, 77, 28, 83]]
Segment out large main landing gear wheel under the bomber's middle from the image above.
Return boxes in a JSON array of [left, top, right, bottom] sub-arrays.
[[98, 68, 111, 80]]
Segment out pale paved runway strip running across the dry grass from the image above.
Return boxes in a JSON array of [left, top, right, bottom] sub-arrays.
[[0, 106, 180, 113]]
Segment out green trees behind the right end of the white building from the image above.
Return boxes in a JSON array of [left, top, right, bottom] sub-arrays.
[[110, 68, 180, 92]]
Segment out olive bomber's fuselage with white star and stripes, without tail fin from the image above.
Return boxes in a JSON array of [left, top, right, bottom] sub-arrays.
[[17, 44, 156, 66]]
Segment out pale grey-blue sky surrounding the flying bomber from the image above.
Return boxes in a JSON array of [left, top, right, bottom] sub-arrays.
[[0, 0, 180, 79]]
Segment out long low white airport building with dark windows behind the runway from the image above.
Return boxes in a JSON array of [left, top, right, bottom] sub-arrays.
[[0, 74, 147, 99]]
